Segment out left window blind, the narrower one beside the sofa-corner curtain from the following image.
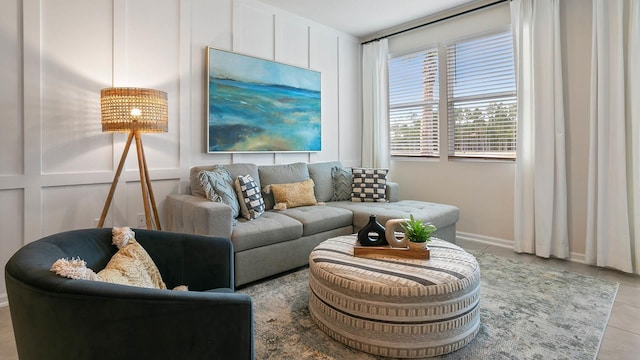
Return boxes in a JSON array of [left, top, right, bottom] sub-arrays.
[[389, 48, 440, 156]]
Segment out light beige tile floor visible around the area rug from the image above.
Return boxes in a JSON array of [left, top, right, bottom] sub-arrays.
[[0, 241, 640, 360]]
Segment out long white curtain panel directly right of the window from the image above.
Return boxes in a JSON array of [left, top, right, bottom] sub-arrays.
[[511, 0, 569, 258]]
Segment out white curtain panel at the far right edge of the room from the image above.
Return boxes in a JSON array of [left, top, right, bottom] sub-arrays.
[[586, 0, 640, 273]]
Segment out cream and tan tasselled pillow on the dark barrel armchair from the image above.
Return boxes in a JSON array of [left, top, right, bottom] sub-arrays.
[[51, 227, 167, 289]]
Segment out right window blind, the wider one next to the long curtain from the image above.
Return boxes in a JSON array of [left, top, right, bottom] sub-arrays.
[[446, 31, 517, 159]]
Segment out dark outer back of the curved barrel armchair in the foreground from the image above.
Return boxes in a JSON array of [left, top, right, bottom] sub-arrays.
[[7, 275, 254, 359]]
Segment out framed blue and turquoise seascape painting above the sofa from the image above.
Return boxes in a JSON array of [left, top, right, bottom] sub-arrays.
[[207, 47, 322, 153]]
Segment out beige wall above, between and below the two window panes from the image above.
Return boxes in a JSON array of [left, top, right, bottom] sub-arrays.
[[389, 3, 515, 243]]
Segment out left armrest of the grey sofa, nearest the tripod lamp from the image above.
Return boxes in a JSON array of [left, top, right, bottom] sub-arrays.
[[166, 194, 233, 238]]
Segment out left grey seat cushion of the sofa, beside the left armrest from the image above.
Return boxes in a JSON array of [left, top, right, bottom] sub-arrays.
[[231, 211, 302, 252]]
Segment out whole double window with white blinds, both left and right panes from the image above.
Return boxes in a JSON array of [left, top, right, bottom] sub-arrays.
[[389, 31, 517, 159]]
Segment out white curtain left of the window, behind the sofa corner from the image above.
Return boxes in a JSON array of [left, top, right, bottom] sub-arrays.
[[362, 39, 389, 169]]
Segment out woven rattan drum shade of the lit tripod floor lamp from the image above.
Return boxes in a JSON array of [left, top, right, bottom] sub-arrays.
[[100, 88, 169, 132]]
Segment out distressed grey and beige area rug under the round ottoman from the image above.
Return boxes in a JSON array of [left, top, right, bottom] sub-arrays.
[[239, 252, 618, 360]]
